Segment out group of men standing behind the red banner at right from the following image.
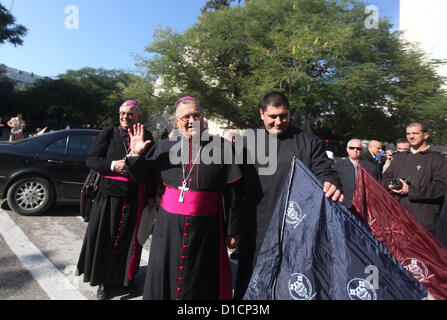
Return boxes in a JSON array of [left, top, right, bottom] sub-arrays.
[[335, 122, 447, 240]]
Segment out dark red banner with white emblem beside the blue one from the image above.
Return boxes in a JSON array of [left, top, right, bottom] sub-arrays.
[[352, 164, 447, 300]]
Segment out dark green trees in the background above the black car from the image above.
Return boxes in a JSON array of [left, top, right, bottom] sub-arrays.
[[6, 68, 137, 129]]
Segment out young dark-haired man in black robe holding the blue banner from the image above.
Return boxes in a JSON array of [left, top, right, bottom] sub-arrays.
[[235, 92, 343, 299]]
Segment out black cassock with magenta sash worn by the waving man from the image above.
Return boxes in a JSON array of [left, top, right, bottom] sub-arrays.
[[130, 136, 241, 300]]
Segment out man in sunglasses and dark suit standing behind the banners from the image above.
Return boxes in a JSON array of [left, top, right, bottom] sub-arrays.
[[335, 139, 379, 209]]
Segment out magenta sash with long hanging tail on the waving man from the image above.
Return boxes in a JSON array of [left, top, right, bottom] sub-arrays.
[[160, 186, 232, 300]]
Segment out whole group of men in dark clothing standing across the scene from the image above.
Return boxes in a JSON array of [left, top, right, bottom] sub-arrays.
[[73, 92, 447, 300]]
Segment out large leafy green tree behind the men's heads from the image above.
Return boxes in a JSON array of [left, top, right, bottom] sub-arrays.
[[134, 0, 447, 142]]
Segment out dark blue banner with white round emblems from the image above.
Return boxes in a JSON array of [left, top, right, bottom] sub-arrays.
[[244, 159, 428, 300]]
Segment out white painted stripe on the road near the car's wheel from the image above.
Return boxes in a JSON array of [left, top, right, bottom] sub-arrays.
[[0, 209, 87, 300]]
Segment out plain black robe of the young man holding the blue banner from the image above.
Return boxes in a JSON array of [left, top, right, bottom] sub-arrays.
[[235, 126, 341, 299]]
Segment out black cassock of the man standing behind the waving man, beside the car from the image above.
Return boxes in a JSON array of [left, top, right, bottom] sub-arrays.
[[77, 126, 155, 286]]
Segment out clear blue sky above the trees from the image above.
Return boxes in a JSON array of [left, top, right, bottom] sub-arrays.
[[0, 0, 399, 77]]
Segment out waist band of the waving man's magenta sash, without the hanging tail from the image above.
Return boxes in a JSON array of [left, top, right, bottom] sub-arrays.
[[160, 186, 222, 217]]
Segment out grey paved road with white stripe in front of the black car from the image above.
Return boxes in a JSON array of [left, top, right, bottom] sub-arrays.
[[0, 205, 150, 300]]
